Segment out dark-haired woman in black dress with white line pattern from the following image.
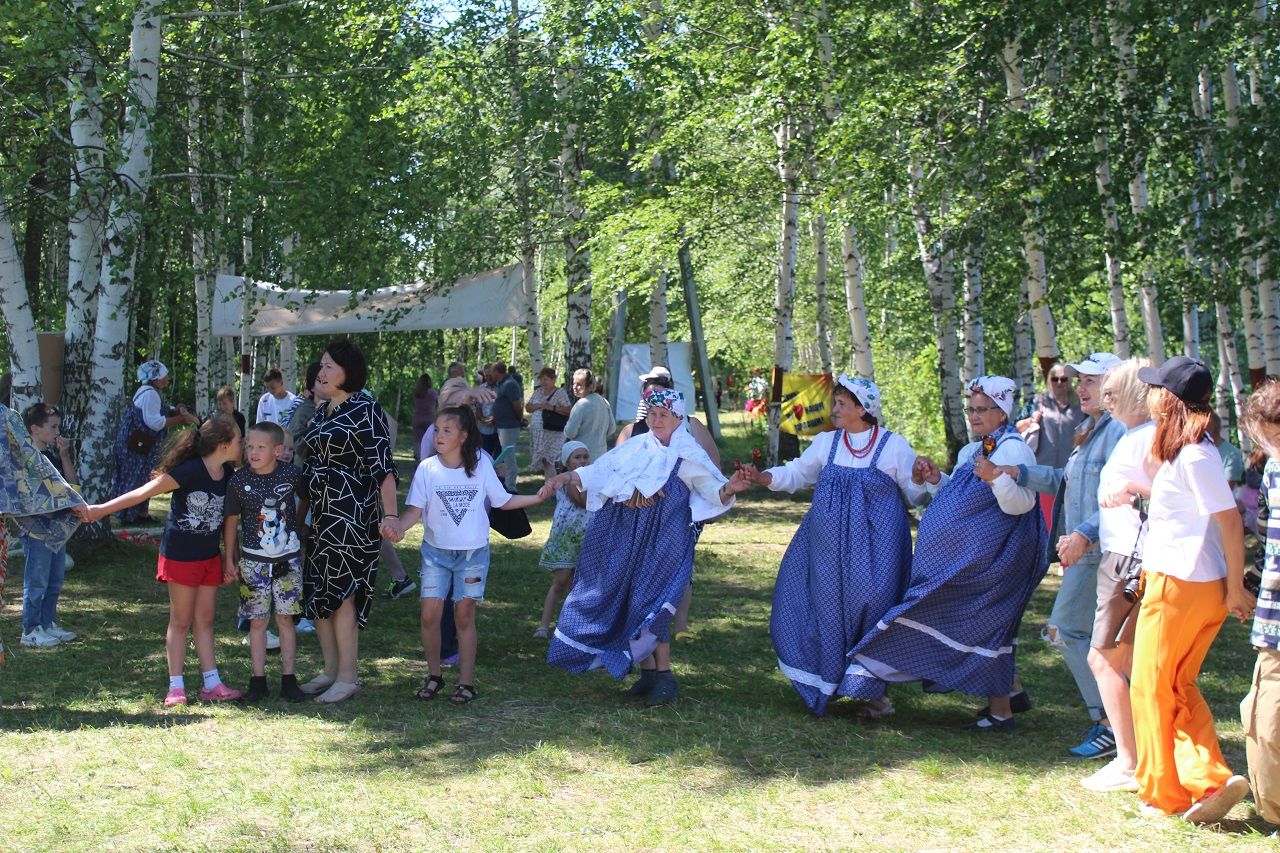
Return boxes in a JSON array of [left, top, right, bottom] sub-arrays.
[[302, 341, 397, 703]]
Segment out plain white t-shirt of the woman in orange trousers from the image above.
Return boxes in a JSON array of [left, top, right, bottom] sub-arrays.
[[1142, 441, 1235, 583]]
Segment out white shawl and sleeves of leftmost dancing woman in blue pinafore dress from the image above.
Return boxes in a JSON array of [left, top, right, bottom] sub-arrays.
[[577, 419, 728, 521]]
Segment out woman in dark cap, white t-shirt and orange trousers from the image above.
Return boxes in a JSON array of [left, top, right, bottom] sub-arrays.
[[1130, 356, 1254, 824]]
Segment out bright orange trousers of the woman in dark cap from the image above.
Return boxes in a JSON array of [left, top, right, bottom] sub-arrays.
[[1129, 571, 1231, 815]]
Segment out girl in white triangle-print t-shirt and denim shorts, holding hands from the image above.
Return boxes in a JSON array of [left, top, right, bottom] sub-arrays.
[[385, 406, 543, 704]]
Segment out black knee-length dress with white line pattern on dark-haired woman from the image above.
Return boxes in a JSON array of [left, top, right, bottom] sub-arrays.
[[302, 391, 398, 628]]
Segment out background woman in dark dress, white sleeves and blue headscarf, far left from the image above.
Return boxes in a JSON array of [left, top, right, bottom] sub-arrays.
[[111, 360, 198, 524]]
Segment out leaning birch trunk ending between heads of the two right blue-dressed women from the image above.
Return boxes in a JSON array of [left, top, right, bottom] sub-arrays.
[[908, 160, 969, 457]]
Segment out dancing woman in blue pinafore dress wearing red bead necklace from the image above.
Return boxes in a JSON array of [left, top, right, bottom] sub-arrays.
[[744, 375, 925, 717]]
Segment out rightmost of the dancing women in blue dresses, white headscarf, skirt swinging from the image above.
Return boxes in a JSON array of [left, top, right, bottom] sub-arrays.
[[846, 377, 1048, 731]]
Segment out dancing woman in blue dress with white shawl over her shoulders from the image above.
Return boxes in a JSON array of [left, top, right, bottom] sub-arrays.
[[543, 388, 750, 706]]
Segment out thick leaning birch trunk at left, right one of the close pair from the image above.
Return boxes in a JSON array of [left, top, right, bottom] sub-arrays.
[[79, 0, 161, 502]]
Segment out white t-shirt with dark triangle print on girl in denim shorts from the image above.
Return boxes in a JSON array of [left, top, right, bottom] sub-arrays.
[[404, 453, 511, 551]]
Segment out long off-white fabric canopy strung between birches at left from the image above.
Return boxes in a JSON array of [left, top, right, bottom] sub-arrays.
[[212, 264, 527, 337]]
